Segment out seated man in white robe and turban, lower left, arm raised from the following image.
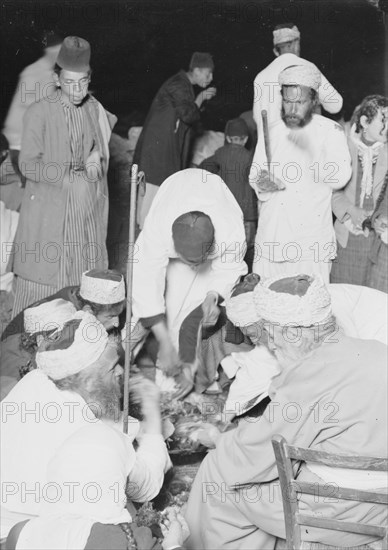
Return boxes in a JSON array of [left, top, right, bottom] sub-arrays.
[[1, 311, 171, 549]]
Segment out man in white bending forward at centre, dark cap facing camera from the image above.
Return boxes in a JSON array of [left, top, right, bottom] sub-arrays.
[[131, 168, 247, 402]]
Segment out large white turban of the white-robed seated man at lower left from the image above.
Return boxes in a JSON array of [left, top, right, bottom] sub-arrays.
[[36, 311, 108, 380]]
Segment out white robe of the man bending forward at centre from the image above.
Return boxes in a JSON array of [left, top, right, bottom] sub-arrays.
[[133, 168, 247, 346]]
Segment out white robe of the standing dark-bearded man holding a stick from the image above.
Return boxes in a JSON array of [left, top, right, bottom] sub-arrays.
[[249, 115, 351, 282]]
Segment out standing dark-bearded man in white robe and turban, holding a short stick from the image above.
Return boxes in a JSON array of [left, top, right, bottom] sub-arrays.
[[250, 64, 351, 283]]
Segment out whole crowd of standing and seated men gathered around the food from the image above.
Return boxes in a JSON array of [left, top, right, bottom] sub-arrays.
[[0, 20, 388, 550]]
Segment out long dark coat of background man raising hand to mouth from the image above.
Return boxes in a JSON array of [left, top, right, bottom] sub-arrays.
[[134, 71, 200, 185]]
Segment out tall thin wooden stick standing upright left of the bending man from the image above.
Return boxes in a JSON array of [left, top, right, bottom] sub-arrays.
[[123, 164, 138, 433]]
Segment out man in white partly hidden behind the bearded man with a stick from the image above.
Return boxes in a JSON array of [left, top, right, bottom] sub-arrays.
[[253, 23, 342, 136]]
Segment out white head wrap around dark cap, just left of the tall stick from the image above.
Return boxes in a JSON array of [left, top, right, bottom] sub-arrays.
[[79, 269, 125, 305]]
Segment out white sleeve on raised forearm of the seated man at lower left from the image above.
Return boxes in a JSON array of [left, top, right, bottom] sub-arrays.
[[127, 434, 171, 502]]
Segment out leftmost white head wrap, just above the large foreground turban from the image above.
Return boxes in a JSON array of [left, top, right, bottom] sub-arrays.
[[24, 298, 77, 334]]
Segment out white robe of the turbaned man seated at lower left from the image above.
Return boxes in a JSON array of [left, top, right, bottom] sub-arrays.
[[0, 370, 171, 547]]
